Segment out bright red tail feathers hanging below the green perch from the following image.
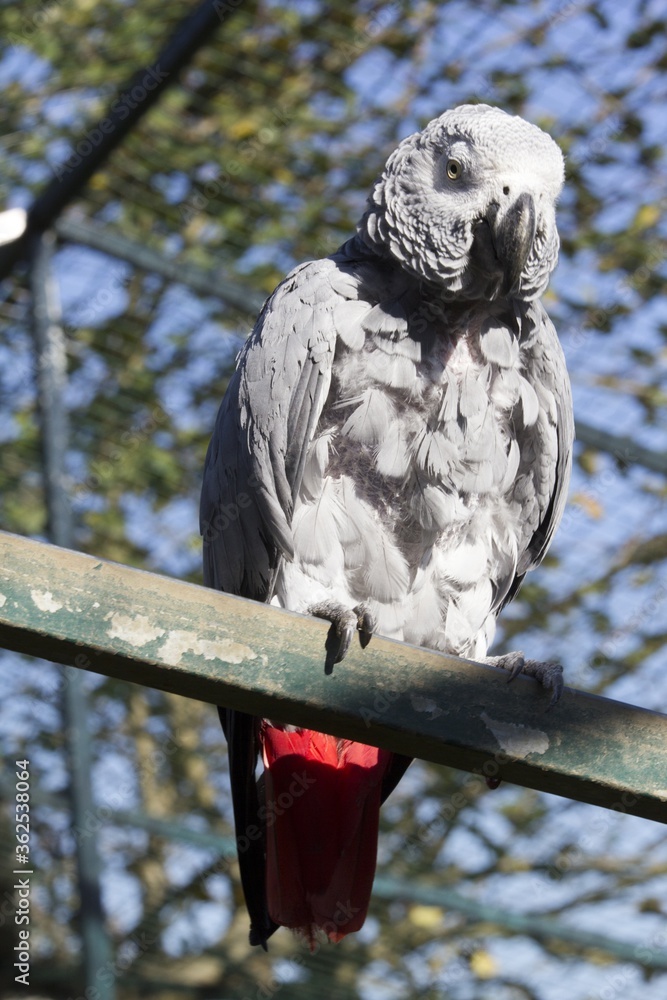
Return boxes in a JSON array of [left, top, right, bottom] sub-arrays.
[[262, 722, 392, 943]]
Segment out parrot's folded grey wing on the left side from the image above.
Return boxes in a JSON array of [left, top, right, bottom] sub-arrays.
[[200, 259, 337, 601]]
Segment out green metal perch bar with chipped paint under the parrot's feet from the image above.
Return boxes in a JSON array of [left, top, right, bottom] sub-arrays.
[[0, 533, 667, 823]]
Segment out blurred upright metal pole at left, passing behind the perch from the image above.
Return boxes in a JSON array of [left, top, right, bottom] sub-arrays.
[[30, 232, 115, 1000]]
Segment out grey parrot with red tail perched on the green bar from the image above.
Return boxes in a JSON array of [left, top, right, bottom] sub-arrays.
[[201, 105, 574, 947]]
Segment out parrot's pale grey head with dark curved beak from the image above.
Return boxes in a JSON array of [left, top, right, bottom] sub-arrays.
[[359, 104, 564, 301]]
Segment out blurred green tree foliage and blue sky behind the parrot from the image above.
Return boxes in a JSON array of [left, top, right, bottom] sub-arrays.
[[0, 0, 667, 1000]]
